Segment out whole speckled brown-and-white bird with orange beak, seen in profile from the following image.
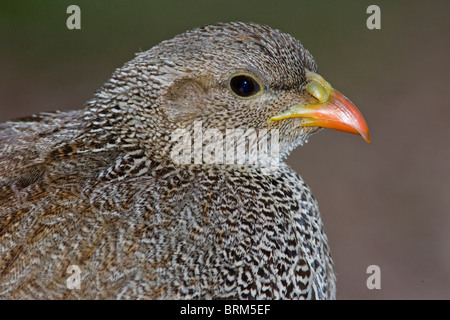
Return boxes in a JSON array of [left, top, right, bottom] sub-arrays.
[[0, 22, 370, 300]]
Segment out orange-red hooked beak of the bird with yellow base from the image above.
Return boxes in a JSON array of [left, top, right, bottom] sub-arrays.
[[269, 72, 370, 143]]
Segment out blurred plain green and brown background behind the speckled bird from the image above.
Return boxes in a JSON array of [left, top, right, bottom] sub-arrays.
[[0, 0, 450, 299]]
